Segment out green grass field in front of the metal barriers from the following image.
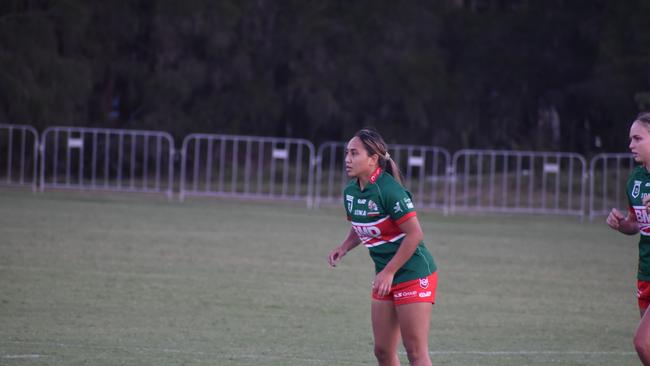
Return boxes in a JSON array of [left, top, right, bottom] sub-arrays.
[[0, 189, 639, 366]]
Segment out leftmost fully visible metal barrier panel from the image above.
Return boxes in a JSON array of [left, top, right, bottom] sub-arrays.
[[41, 127, 174, 199]]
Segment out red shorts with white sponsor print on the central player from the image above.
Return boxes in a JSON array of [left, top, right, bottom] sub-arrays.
[[372, 272, 438, 306]]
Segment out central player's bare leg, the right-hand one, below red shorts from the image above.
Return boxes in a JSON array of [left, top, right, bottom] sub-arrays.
[[397, 302, 431, 366]]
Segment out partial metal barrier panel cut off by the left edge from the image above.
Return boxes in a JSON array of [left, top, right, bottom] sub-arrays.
[[0, 124, 38, 191]]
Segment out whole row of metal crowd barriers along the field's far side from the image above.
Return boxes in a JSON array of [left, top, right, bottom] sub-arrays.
[[0, 124, 634, 218]]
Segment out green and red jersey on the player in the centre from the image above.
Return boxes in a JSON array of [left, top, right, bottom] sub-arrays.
[[343, 168, 436, 284]]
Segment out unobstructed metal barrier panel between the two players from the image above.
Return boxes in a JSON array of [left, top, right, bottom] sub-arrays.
[[450, 150, 588, 216]]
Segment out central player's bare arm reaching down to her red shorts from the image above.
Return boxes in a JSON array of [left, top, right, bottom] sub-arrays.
[[373, 215, 424, 296]]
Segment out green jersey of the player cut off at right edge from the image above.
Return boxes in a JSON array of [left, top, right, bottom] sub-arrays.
[[625, 166, 650, 281]]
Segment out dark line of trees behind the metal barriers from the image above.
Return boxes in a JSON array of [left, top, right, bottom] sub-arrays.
[[0, 0, 650, 154]]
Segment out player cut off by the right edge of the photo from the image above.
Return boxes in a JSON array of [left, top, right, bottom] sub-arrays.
[[607, 113, 650, 366]]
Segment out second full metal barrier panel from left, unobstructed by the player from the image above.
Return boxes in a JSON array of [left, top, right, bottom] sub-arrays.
[[180, 134, 315, 207]]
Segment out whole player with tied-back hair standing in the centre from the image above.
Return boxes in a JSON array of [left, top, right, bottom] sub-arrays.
[[328, 129, 438, 366]]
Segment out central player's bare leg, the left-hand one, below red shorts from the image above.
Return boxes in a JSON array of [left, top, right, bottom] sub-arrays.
[[371, 299, 400, 366]]
